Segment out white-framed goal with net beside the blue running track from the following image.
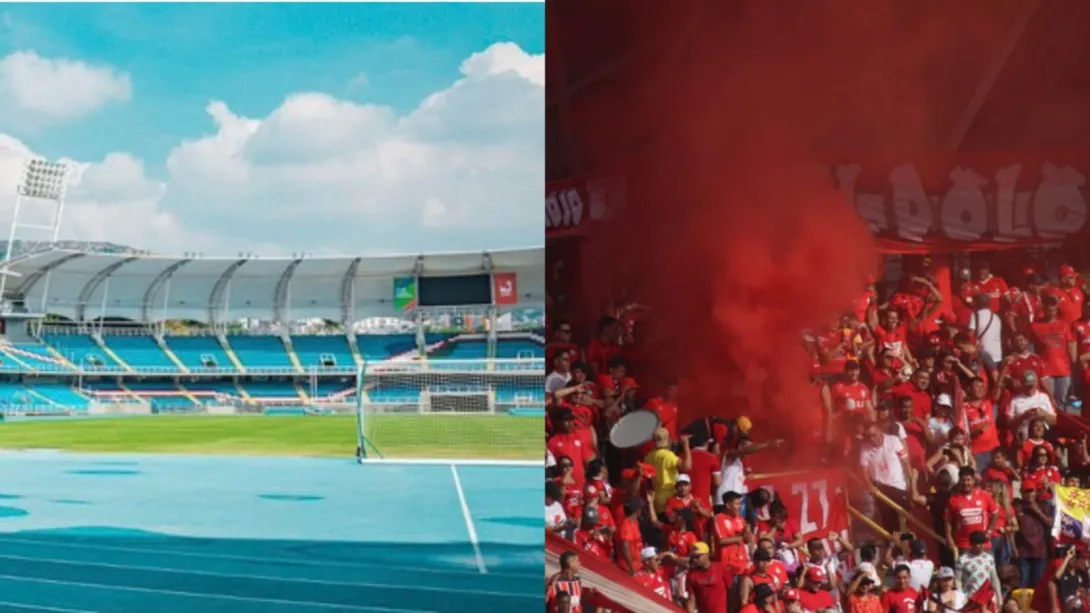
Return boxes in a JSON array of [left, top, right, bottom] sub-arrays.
[[355, 359, 545, 464]]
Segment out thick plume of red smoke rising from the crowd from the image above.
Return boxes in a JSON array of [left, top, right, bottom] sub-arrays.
[[580, 0, 1037, 449]]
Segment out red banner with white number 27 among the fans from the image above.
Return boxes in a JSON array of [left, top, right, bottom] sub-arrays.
[[750, 469, 850, 539]]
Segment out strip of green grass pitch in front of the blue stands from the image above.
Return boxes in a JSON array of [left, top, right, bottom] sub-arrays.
[[0, 414, 545, 460]]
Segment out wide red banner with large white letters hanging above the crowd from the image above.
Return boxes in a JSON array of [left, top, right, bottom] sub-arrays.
[[832, 151, 1090, 253]]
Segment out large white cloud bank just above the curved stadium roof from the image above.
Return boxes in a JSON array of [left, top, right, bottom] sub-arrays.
[[0, 44, 545, 255]]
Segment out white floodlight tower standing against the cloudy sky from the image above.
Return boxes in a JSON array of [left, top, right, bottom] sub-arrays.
[[0, 159, 69, 299]]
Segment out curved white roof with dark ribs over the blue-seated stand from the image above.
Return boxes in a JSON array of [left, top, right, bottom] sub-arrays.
[[3, 248, 545, 323]]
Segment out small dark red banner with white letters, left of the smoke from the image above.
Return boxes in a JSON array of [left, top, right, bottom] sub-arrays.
[[545, 176, 625, 238]]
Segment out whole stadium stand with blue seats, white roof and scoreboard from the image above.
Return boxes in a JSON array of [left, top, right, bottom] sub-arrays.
[[0, 249, 544, 416]]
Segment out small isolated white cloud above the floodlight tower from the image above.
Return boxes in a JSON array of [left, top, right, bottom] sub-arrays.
[[0, 51, 132, 125]]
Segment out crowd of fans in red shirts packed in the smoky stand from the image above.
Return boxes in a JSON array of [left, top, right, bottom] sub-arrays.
[[545, 262, 1090, 613]]
